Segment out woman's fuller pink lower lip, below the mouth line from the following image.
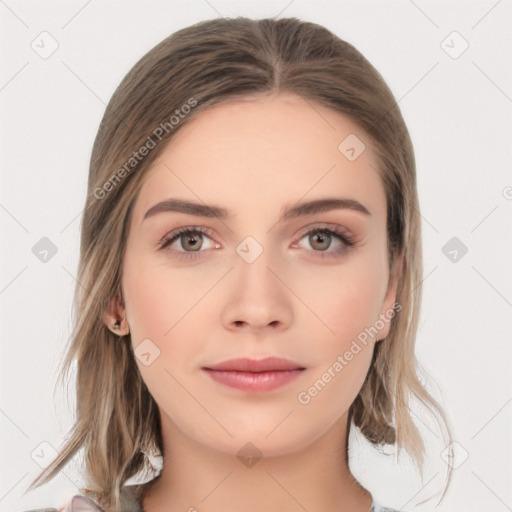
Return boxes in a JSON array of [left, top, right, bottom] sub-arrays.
[[204, 368, 303, 393]]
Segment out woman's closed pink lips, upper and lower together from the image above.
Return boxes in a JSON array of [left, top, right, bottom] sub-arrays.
[[202, 357, 305, 393]]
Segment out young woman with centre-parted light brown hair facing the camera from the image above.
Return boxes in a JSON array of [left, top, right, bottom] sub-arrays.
[[25, 18, 451, 512]]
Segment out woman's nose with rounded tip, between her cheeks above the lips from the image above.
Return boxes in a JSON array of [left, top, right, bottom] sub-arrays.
[[221, 242, 293, 334]]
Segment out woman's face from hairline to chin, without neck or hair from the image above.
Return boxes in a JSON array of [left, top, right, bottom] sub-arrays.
[[115, 93, 395, 456]]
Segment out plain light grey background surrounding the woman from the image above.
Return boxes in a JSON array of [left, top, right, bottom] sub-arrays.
[[0, 0, 512, 512]]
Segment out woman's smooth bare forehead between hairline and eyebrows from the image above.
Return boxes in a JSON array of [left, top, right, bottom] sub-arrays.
[[131, 93, 385, 224]]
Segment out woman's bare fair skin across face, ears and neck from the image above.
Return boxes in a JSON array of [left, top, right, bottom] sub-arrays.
[[106, 93, 398, 512]]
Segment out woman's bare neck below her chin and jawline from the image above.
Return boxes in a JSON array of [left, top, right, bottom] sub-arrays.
[[142, 415, 372, 512]]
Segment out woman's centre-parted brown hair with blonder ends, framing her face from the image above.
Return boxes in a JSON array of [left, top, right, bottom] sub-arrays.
[[28, 17, 451, 512]]
